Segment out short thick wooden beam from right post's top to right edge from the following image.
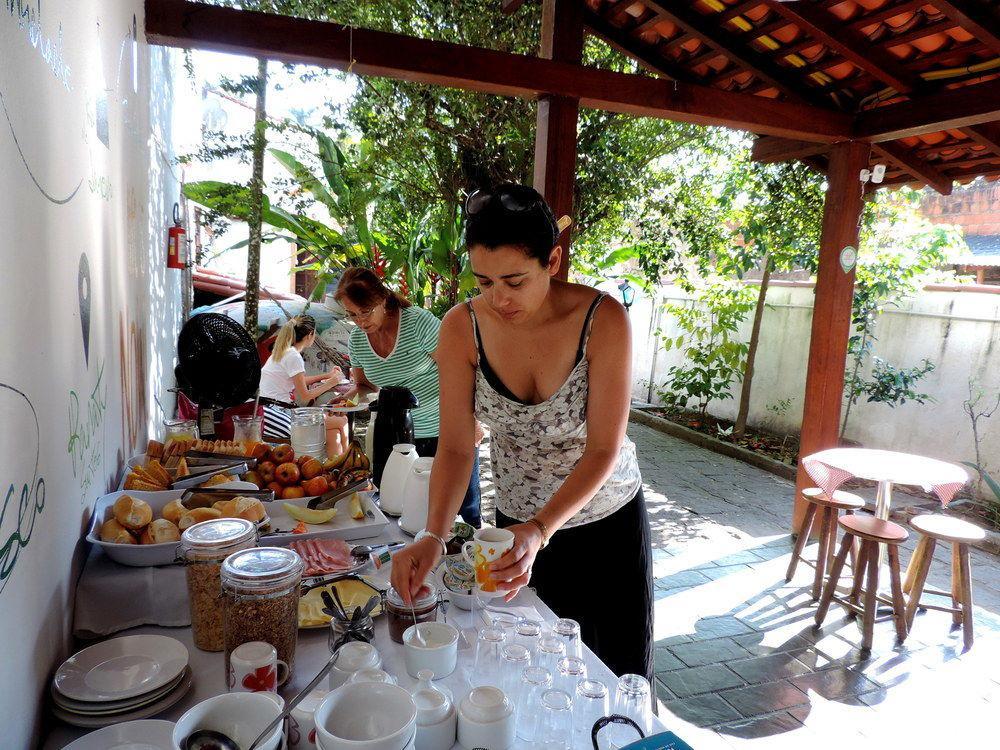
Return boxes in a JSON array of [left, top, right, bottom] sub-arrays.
[[854, 79, 1000, 142]]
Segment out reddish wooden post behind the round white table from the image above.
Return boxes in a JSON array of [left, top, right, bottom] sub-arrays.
[[792, 141, 871, 531]]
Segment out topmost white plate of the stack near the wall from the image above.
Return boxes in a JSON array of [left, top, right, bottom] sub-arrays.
[[54, 635, 188, 701]]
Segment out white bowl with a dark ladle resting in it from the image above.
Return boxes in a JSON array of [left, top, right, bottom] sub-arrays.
[[173, 693, 285, 750]]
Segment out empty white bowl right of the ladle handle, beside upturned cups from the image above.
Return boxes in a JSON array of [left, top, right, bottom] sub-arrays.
[[315, 682, 417, 750]]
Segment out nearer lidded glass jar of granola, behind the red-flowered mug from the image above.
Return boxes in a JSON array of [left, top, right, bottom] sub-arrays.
[[222, 547, 305, 682]]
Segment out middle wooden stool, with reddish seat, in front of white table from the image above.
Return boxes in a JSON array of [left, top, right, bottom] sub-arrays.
[[816, 515, 909, 651]]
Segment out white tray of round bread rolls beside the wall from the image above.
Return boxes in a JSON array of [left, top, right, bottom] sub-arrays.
[[87, 490, 270, 567]]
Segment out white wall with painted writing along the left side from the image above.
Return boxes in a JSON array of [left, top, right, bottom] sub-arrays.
[[0, 0, 182, 748]]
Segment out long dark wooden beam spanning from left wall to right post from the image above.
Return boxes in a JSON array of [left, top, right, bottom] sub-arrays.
[[145, 0, 851, 142]]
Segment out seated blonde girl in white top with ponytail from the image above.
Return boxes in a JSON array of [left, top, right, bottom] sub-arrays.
[[260, 315, 347, 454]]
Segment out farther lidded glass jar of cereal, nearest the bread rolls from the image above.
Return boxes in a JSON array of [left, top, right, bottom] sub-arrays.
[[180, 518, 257, 651]]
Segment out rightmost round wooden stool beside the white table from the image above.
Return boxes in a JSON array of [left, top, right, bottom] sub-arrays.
[[903, 515, 986, 650]]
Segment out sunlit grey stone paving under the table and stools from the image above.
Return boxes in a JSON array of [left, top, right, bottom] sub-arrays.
[[484, 423, 1000, 750]]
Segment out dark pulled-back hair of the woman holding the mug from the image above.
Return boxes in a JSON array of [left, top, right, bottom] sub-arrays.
[[465, 183, 559, 266]]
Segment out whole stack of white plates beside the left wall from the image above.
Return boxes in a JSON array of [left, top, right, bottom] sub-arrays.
[[51, 635, 191, 728]]
